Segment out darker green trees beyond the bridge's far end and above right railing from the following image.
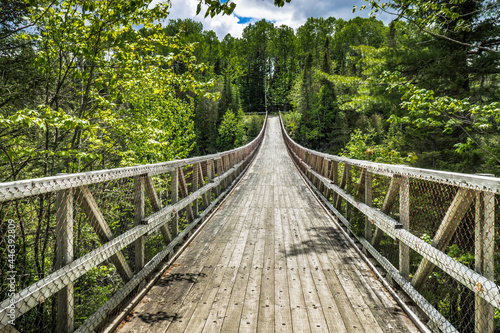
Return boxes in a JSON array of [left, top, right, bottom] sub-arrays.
[[167, 1, 500, 175]]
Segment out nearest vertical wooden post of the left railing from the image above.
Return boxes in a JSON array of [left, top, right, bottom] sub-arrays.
[[55, 189, 75, 332]]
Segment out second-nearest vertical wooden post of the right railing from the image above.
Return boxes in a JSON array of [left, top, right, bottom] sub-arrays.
[[399, 176, 410, 281]]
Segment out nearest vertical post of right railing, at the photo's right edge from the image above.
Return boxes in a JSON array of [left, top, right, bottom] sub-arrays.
[[474, 191, 495, 333]]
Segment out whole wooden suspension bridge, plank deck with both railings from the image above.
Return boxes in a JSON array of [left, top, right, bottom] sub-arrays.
[[0, 116, 500, 333]]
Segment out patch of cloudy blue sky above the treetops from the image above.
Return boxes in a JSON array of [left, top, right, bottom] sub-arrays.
[[153, 0, 391, 39]]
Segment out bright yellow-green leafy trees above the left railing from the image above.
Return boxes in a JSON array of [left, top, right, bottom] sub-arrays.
[[0, 0, 266, 181]]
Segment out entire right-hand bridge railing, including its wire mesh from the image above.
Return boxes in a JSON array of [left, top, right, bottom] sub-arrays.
[[281, 113, 500, 333]]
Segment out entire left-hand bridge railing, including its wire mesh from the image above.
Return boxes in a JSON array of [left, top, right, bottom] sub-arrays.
[[0, 113, 267, 332]]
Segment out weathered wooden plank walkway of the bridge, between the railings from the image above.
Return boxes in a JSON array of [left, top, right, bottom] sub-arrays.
[[118, 117, 418, 333]]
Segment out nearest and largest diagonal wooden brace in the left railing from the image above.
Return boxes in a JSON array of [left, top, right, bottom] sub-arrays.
[[75, 186, 133, 282]]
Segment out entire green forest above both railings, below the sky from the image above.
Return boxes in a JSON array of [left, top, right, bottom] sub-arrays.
[[0, 0, 500, 181]]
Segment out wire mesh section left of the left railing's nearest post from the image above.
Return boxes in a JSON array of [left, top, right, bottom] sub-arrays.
[[0, 193, 56, 332]]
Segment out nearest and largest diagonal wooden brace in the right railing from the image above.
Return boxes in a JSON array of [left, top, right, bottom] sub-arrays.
[[411, 188, 475, 290]]
